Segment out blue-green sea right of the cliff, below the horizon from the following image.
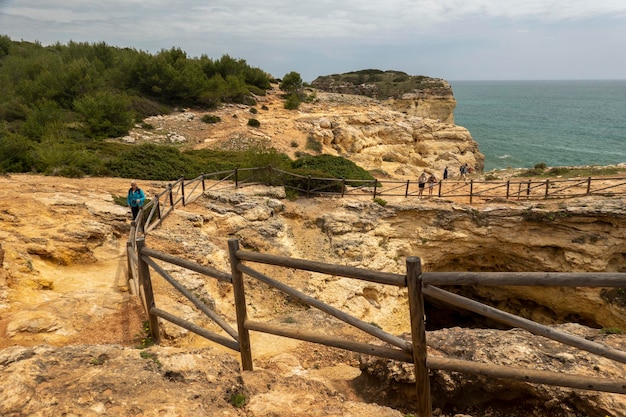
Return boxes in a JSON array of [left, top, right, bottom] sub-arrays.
[[449, 80, 626, 171]]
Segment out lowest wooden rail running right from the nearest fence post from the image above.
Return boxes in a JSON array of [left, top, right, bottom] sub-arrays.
[[426, 356, 626, 394]]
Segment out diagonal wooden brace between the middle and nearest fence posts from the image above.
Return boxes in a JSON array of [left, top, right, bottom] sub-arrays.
[[237, 264, 413, 352]]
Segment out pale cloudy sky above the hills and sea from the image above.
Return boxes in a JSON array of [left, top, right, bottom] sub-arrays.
[[0, 0, 626, 82]]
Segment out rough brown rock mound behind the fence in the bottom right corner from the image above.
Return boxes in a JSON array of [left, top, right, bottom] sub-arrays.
[[360, 324, 626, 417]]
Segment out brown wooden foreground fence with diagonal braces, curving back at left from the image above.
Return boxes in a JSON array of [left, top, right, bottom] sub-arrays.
[[127, 171, 626, 417]]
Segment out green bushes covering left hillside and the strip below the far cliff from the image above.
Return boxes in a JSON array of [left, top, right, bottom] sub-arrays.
[[0, 36, 373, 184]]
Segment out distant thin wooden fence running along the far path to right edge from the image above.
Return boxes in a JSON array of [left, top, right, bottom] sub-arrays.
[[129, 166, 626, 208]]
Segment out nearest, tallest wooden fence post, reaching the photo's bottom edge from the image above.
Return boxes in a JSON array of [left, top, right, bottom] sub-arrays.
[[406, 256, 432, 417]]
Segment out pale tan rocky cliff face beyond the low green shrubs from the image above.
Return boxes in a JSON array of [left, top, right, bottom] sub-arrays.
[[121, 83, 484, 179]]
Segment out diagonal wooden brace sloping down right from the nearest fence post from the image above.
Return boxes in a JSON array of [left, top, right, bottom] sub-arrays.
[[422, 285, 626, 363]]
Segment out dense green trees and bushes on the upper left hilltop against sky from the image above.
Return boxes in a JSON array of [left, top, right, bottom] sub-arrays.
[[0, 36, 270, 141]]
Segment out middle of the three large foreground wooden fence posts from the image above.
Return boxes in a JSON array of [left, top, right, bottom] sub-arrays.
[[228, 239, 252, 371]]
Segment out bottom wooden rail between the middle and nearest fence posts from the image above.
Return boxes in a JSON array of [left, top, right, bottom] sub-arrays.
[[244, 320, 413, 363]]
